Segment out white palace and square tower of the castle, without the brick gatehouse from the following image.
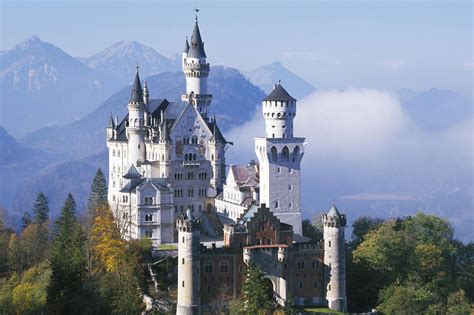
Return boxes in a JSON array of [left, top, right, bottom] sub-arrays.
[[107, 18, 305, 246]]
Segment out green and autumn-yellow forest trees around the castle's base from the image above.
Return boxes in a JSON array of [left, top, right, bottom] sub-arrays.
[[0, 170, 474, 314]]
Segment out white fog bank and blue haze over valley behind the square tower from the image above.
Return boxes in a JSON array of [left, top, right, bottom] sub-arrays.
[[227, 89, 474, 241]]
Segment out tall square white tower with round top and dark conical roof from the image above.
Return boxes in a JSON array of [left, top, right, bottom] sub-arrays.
[[255, 84, 306, 235]]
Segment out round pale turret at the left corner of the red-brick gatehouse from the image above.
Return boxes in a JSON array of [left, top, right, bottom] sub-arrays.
[[176, 209, 201, 315]]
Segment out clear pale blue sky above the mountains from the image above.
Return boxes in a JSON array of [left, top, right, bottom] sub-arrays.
[[0, 0, 474, 96]]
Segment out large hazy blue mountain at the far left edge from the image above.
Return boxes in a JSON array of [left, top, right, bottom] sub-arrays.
[[0, 36, 120, 135]]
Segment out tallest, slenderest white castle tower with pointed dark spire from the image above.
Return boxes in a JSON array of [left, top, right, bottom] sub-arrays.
[[181, 15, 212, 119]]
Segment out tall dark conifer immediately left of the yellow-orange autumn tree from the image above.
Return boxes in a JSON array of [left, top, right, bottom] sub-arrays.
[[47, 194, 86, 314]]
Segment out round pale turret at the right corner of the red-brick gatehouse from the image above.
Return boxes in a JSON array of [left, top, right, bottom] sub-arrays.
[[323, 206, 347, 312]]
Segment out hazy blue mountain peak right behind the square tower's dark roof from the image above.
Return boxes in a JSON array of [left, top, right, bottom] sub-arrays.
[[242, 61, 316, 100]]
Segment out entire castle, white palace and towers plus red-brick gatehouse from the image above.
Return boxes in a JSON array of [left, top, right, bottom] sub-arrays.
[[107, 17, 346, 314]]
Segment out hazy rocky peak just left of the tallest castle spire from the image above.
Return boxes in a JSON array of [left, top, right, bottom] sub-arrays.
[[78, 41, 180, 84]]
